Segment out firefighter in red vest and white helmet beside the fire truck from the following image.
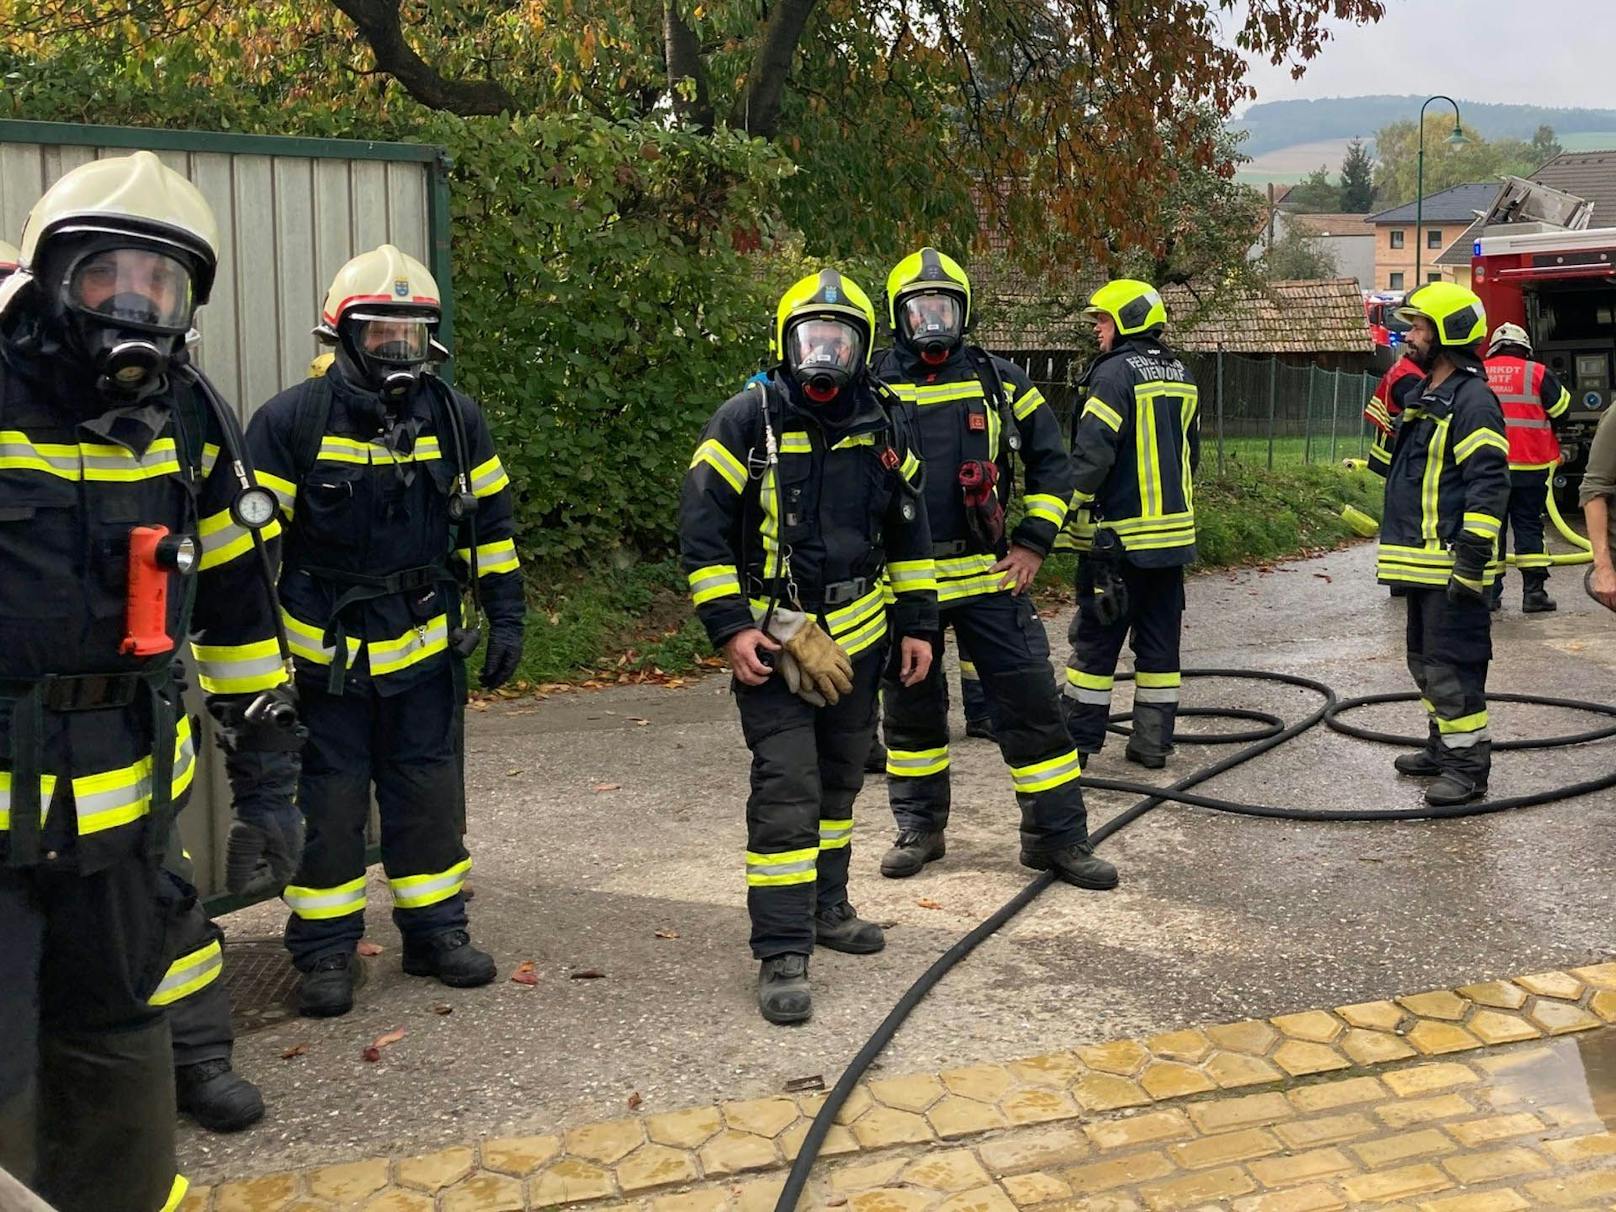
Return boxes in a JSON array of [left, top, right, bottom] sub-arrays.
[[1485, 323, 1571, 614]]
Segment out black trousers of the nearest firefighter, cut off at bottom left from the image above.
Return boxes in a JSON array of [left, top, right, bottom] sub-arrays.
[[0, 842, 189, 1212]]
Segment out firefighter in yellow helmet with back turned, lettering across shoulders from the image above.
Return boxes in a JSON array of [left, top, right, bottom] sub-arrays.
[[1063, 278, 1201, 769]]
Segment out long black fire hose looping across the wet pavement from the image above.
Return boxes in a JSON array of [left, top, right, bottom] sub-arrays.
[[774, 669, 1616, 1212]]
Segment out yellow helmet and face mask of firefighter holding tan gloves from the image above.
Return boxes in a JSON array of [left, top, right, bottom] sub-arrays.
[[771, 268, 876, 404]]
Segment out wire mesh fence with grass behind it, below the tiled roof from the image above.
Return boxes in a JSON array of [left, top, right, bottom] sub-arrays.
[[1008, 354, 1378, 473]]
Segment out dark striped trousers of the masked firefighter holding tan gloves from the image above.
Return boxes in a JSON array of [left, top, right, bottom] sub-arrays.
[[734, 645, 886, 960]]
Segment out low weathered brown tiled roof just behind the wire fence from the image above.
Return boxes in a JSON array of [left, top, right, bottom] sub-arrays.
[[971, 271, 1374, 354]]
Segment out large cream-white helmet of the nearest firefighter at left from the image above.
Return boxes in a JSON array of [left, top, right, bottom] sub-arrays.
[[19, 152, 218, 307]]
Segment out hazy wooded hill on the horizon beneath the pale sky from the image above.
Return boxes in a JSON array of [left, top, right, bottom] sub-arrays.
[[1228, 95, 1616, 157]]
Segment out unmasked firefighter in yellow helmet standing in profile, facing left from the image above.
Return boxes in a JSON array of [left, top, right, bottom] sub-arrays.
[[1377, 283, 1509, 806]]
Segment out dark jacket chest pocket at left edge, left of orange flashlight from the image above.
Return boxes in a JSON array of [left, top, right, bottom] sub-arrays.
[[0, 472, 78, 619]]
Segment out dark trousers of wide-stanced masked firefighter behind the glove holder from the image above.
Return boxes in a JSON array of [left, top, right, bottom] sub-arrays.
[[881, 593, 1088, 853]]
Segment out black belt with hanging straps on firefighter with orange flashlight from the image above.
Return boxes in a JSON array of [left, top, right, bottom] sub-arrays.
[[0, 654, 181, 866]]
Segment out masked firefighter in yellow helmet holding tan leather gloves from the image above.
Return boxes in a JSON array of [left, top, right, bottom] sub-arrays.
[[679, 270, 937, 1023]]
